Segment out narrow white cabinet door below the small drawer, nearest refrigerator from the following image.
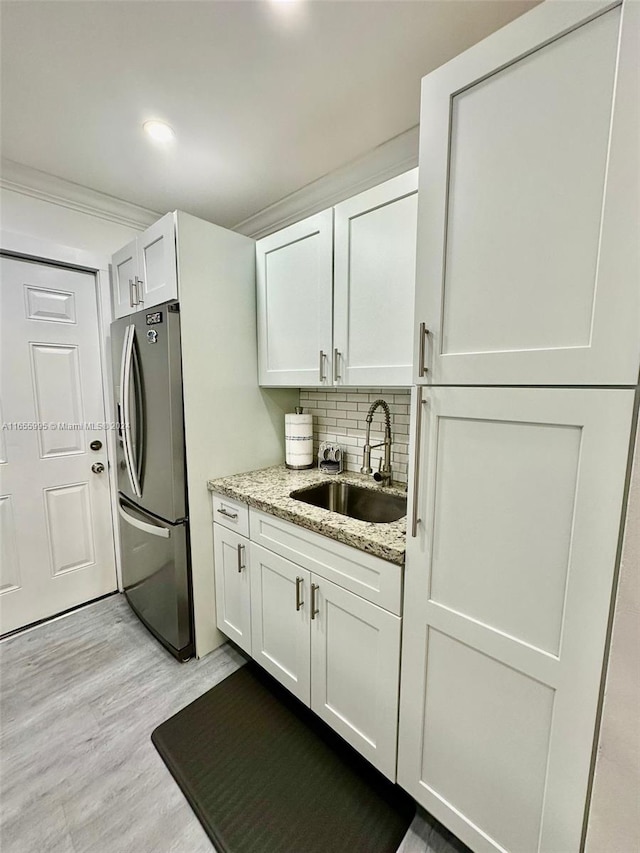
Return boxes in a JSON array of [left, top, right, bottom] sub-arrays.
[[213, 524, 251, 654]]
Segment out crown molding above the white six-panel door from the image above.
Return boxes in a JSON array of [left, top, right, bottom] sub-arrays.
[[0, 157, 161, 230]]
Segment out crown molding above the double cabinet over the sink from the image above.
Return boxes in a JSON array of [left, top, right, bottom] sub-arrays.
[[233, 125, 419, 239]]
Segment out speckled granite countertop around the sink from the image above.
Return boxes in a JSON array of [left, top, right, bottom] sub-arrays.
[[208, 465, 407, 566]]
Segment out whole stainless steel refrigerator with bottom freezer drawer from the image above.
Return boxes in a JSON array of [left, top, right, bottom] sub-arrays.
[[111, 302, 194, 660]]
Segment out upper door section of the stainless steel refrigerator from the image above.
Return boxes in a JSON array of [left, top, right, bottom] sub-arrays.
[[111, 303, 187, 522]]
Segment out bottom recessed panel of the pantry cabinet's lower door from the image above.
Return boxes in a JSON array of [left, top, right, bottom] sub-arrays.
[[420, 628, 556, 853]]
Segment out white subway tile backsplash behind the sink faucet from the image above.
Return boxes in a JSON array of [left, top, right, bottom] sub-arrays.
[[300, 388, 411, 483]]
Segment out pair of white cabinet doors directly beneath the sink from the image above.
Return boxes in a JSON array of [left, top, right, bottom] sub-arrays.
[[251, 542, 402, 780]]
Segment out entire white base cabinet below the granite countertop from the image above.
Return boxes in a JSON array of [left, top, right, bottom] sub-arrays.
[[213, 495, 402, 781]]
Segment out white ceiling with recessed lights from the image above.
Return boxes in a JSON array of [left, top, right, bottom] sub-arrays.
[[0, 0, 538, 227]]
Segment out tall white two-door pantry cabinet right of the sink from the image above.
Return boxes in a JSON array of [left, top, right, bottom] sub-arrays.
[[398, 0, 640, 853]]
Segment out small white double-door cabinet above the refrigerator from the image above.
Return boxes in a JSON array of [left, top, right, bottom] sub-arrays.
[[112, 213, 178, 319]]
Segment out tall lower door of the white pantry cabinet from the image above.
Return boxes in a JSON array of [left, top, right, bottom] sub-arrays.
[[398, 388, 634, 853]]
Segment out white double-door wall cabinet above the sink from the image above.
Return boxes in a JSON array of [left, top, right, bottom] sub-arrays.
[[256, 169, 418, 387]]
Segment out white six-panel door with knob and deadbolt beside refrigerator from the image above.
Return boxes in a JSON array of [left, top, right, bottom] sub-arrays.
[[0, 257, 116, 633]]
